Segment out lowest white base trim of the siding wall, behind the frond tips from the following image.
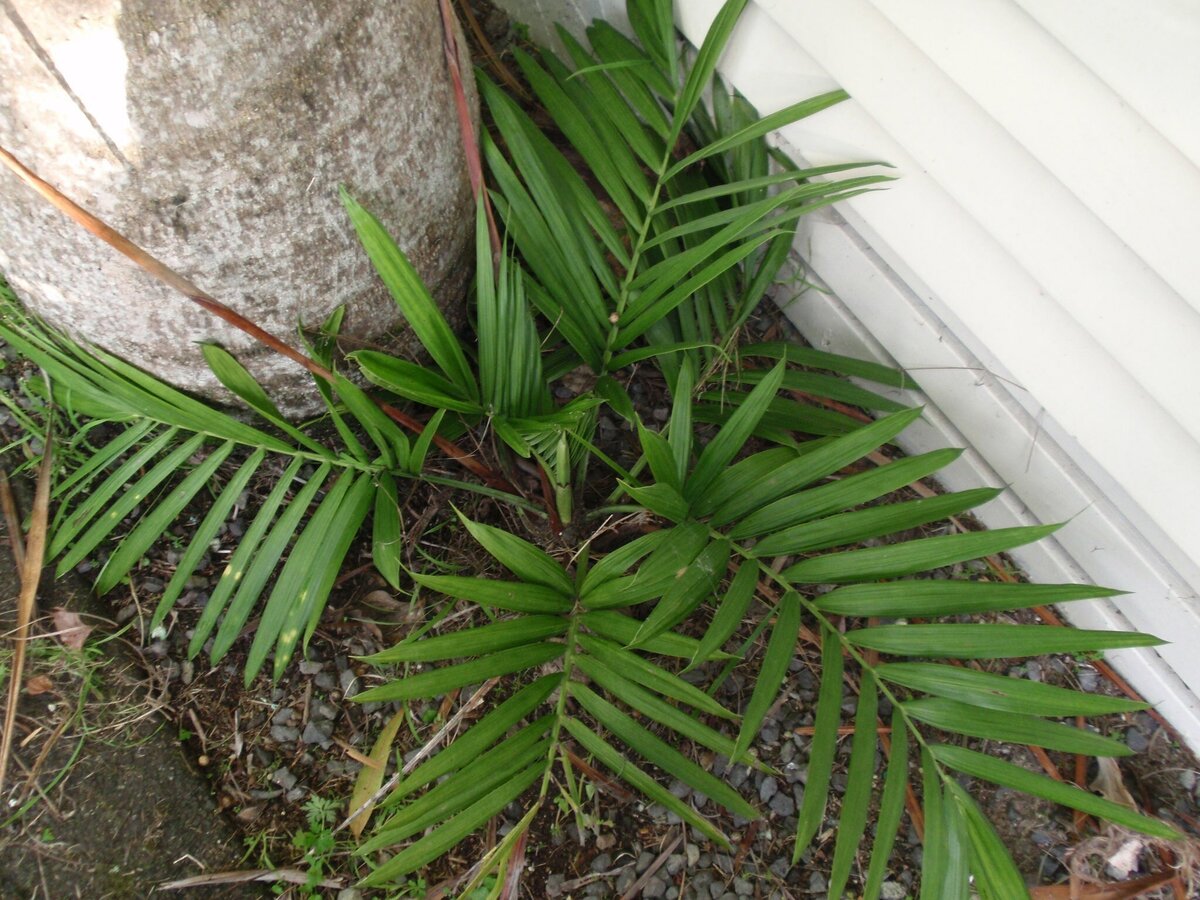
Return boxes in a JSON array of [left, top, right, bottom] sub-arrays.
[[779, 214, 1200, 752]]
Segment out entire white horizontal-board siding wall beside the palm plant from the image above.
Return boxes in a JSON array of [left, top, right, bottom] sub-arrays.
[[494, 0, 1200, 749]]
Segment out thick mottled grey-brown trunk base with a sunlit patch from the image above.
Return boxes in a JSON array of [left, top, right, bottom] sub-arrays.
[[0, 0, 474, 410]]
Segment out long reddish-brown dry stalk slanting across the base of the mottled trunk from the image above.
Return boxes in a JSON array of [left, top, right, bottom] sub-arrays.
[[0, 146, 518, 493]]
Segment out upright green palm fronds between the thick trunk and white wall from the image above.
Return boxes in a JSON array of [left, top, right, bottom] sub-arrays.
[[480, 1, 887, 384]]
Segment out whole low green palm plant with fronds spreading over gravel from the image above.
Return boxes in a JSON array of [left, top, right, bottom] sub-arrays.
[[0, 0, 1175, 900]]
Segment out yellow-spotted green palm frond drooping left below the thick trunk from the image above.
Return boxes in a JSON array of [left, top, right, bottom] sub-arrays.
[[0, 305, 409, 682]]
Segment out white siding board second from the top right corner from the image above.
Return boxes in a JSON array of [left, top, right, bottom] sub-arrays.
[[872, 0, 1200, 319]]
